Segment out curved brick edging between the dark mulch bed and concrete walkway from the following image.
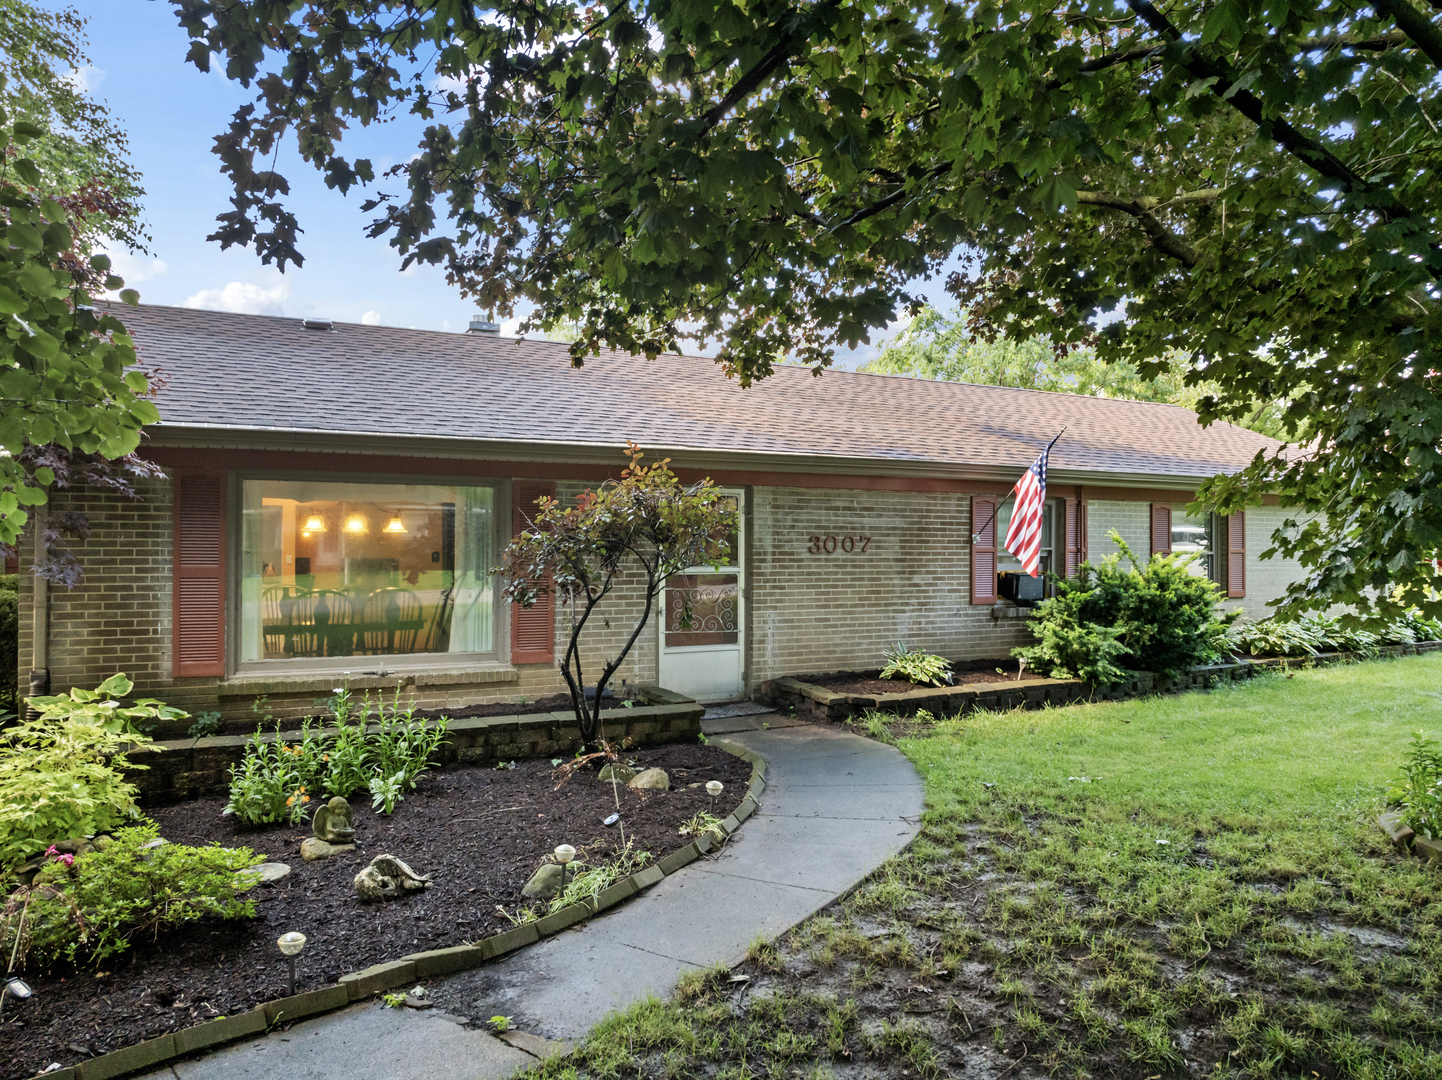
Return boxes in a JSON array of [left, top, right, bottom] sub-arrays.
[[37, 738, 766, 1080]]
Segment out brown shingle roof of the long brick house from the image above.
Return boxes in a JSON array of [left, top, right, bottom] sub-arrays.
[[115, 298, 1273, 479]]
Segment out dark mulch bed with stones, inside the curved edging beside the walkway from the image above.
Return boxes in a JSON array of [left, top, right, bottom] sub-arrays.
[[0, 744, 751, 1080]]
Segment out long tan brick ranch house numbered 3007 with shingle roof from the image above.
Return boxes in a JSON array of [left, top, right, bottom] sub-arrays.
[[20, 307, 1298, 718]]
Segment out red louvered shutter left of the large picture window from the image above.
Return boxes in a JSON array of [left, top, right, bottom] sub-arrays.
[[172, 476, 225, 679]]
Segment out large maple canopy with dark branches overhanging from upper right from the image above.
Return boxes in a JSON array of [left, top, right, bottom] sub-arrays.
[[172, 0, 1442, 614]]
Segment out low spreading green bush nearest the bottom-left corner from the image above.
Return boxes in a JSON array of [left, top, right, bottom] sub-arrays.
[[0, 822, 260, 969]]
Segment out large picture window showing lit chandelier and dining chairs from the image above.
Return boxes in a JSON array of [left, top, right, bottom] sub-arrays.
[[239, 480, 496, 662]]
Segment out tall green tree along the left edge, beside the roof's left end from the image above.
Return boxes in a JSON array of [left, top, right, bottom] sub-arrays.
[[0, 0, 159, 585]]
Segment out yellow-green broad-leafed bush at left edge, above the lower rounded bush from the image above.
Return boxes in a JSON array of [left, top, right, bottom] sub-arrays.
[[0, 675, 186, 867]]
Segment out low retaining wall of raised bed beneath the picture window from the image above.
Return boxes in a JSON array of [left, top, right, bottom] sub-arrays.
[[125, 686, 705, 803]]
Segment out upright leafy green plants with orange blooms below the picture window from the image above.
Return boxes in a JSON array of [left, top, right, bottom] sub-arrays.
[[225, 688, 447, 825]]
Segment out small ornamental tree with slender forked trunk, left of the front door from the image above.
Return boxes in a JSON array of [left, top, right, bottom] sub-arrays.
[[493, 443, 737, 745]]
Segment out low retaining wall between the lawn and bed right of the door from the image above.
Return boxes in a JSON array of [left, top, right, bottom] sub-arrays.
[[757, 642, 1442, 722]]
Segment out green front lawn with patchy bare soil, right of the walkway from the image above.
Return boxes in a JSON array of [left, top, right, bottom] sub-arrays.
[[530, 655, 1442, 1080]]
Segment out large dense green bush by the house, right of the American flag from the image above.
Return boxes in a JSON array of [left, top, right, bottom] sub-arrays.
[[1012, 531, 1240, 685]]
